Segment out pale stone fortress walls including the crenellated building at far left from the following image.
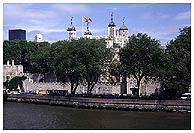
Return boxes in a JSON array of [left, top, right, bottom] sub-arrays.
[[3, 61, 161, 96]]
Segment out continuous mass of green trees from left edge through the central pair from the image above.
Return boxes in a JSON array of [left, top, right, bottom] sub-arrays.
[[3, 38, 113, 94]]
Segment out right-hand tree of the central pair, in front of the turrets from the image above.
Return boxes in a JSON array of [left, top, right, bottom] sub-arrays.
[[80, 39, 114, 95]]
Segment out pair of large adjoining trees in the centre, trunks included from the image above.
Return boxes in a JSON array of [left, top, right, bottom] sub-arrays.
[[51, 38, 112, 94]]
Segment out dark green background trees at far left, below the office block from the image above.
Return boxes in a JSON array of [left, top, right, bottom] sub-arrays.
[[3, 40, 52, 77]]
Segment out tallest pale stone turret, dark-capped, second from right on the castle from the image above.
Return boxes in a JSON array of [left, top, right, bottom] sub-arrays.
[[108, 12, 116, 40]]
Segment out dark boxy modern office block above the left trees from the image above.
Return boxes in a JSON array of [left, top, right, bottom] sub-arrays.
[[9, 29, 26, 40]]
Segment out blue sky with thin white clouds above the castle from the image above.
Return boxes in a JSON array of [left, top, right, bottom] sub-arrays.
[[3, 3, 191, 45]]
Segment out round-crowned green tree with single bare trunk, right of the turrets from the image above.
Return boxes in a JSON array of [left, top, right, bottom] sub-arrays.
[[119, 33, 163, 95]]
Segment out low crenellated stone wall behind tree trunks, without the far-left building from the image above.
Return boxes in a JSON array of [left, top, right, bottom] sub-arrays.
[[20, 74, 161, 96]]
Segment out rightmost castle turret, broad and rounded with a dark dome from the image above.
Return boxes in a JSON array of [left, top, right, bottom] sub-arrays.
[[119, 17, 129, 47]]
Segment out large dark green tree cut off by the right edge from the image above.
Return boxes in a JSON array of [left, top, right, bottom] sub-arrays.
[[165, 26, 191, 95]]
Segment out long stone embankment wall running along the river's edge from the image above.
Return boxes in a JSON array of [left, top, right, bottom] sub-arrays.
[[7, 94, 191, 112]]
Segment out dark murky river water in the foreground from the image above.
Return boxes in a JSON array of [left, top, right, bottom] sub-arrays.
[[3, 102, 191, 130]]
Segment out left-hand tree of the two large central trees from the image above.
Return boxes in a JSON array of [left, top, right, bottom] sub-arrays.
[[51, 40, 85, 95]]
